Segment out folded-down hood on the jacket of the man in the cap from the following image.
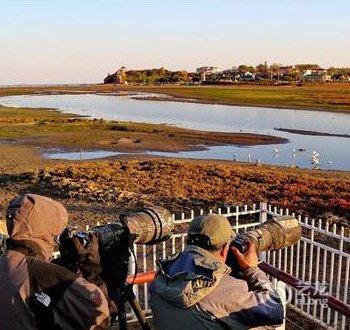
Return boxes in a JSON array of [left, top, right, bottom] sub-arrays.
[[150, 245, 231, 308]]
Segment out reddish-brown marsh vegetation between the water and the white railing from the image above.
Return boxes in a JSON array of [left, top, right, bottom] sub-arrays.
[[39, 159, 350, 221]]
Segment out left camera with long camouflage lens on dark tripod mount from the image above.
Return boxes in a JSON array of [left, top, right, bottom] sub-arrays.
[[60, 206, 174, 300]]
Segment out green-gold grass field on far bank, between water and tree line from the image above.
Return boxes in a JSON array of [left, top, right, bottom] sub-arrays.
[[121, 84, 350, 112]]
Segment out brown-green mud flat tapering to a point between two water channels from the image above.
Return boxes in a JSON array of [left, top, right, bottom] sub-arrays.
[[0, 102, 288, 152]]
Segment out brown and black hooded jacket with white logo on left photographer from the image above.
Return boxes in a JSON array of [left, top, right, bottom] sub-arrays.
[[0, 194, 109, 330]]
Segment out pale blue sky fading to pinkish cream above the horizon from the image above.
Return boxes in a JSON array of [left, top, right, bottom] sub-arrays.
[[0, 0, 350, 84]]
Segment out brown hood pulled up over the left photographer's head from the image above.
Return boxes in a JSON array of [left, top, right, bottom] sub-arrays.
[[6, 194, 68, 261]]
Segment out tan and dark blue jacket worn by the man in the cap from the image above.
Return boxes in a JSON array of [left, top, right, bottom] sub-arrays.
[[150, 245, 284, 330]]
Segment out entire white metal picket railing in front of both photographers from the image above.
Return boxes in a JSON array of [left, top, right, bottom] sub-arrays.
[[130, 203, 350, 330]]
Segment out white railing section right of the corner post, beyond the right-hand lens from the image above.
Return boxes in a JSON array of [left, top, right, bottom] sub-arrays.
[[267, 207, 350, 329]]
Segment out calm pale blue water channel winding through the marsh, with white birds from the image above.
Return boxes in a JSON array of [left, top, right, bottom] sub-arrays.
[[0, 94, 350, 170]]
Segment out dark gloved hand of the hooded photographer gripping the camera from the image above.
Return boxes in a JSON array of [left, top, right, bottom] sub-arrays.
[[60, 228, 102, 285]]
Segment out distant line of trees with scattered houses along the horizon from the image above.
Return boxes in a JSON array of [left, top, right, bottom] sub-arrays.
[[104, 62, 350, 85]]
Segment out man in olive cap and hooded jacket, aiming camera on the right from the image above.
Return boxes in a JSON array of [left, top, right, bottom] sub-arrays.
[[150, 214, 284, 330]]
